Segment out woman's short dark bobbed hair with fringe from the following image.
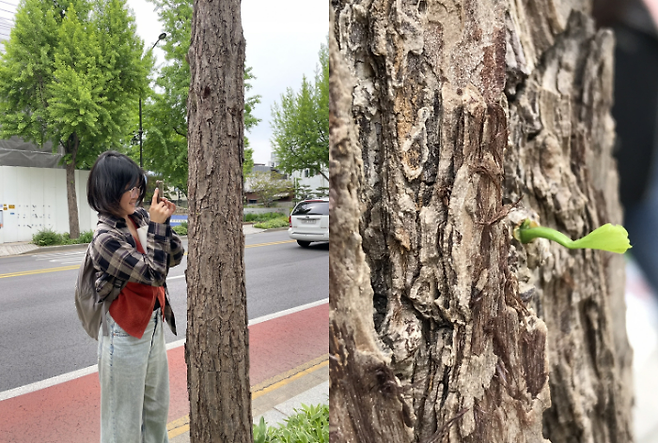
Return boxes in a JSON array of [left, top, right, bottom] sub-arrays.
[[87, 151, 146, 216]]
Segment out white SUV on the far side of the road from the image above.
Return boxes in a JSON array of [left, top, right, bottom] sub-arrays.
[[288, 198, 329, 248]]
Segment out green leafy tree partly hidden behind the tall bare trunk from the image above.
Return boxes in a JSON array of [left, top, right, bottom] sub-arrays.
[[143, 0, 260, 193]]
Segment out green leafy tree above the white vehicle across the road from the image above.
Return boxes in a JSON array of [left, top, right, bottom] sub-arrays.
[[272, 41, 329, 180]]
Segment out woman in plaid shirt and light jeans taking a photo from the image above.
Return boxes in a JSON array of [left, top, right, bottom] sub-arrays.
[[87, 151, 184, 443]]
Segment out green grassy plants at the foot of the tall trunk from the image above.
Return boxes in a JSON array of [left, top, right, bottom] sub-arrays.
[[254, 405, 329, 443]]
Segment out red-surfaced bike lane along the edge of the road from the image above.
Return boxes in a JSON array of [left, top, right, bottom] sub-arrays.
[[0, 303, 329, 443]]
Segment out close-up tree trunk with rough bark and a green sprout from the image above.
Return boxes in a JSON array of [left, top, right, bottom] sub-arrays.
[[330, 0, 632, 443]]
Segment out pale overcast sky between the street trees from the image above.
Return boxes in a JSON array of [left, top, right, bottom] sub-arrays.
[[128, 0, 329, 164]]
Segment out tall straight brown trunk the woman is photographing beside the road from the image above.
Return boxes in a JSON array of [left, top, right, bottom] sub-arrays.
[[185, 0, 252, 443]]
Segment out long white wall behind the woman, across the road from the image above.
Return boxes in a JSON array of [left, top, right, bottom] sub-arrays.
[[0, 166, 98, 243]]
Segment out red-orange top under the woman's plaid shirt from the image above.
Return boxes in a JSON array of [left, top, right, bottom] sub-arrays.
[[110, 220, 165, 338]]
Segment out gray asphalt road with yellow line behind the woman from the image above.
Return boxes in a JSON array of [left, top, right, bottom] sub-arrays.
[[0, 231, 329, 392]]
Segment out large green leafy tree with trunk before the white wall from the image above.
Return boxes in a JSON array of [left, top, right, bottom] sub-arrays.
[[0, 0, 152, 238]]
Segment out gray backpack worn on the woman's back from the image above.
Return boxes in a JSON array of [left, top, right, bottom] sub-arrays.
[[75, 243, 126, 340]]
